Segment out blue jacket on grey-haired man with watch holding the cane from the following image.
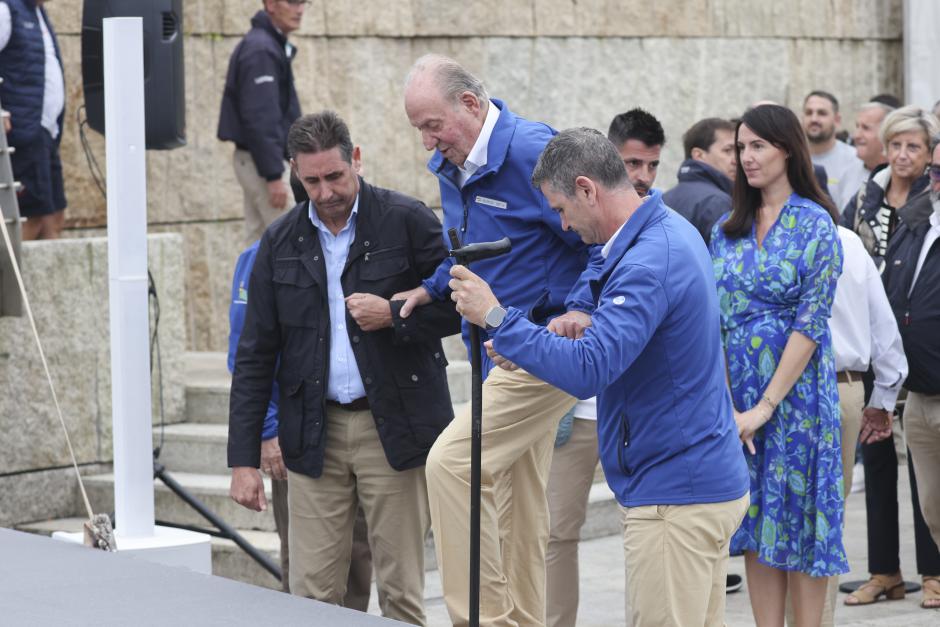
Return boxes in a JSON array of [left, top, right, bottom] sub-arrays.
[[492, 190, 748, 507]]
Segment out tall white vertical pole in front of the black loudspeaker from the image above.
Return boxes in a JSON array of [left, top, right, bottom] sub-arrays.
[[104, 17, 154, 545]]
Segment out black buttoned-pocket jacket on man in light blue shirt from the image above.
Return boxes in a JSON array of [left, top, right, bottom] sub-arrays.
[[228, 182, 460, 477]]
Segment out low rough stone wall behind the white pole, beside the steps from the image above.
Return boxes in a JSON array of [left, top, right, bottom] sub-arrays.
[[0, 234, 185, 526]]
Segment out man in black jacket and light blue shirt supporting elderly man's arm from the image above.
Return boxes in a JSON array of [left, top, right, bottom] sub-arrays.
[[228, 111, 460, 625]]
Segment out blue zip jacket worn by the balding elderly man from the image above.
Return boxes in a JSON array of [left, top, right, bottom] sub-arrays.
[[423, 99, 593, 372]]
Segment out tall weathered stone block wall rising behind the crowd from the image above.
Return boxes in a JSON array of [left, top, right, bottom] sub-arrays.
[[42, 0, 903, 350]]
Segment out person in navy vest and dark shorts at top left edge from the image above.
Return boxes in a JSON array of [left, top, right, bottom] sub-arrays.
[[0, 0, 66, 240]]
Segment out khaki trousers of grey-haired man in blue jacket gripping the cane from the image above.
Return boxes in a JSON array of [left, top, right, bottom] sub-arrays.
[[621, 494, 750, 627]]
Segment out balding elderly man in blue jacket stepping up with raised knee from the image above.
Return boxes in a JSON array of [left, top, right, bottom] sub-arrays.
[[395, 55, 593, 625]]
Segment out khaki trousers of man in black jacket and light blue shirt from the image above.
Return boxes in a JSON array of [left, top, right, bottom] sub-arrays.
[[287, 406, 429, 625]]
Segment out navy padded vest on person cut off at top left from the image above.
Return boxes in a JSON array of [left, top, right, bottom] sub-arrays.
[[0, 0, 64, 147]]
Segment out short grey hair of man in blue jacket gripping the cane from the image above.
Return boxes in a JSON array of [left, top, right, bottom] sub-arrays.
[[532, 126, 632, 198]]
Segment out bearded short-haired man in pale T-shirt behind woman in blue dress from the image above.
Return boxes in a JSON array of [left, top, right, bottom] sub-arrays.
[[803, 90, 868, 209]]
